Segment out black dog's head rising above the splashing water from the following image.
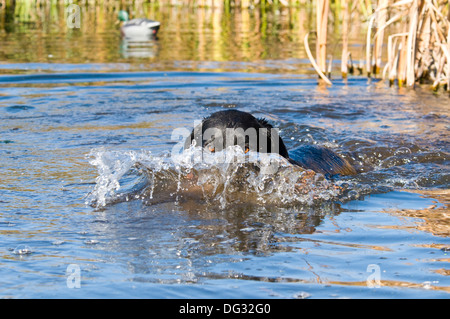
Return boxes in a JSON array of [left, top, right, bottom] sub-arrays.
[[184, 110, 289, 158]]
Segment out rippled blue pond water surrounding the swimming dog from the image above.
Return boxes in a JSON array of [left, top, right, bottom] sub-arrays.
[[0, 4, 450, 298]]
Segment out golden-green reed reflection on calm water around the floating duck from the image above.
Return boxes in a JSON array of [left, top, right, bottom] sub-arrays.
[[0, 3, 365, 74]]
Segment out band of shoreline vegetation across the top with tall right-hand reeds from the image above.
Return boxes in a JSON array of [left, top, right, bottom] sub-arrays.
[[0, 0, 450, 92]]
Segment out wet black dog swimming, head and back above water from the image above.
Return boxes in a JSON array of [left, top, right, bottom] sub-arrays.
[[184, 110, 356, 177]]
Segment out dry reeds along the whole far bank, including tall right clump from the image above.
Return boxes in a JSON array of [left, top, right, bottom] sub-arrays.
[[0, 0, 450, 91]]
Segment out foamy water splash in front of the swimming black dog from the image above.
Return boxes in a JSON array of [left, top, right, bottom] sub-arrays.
[[86, 146, 341, 208]]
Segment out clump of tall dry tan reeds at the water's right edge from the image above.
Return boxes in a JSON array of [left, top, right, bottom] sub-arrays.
[[305, 0, 450, 91]]
